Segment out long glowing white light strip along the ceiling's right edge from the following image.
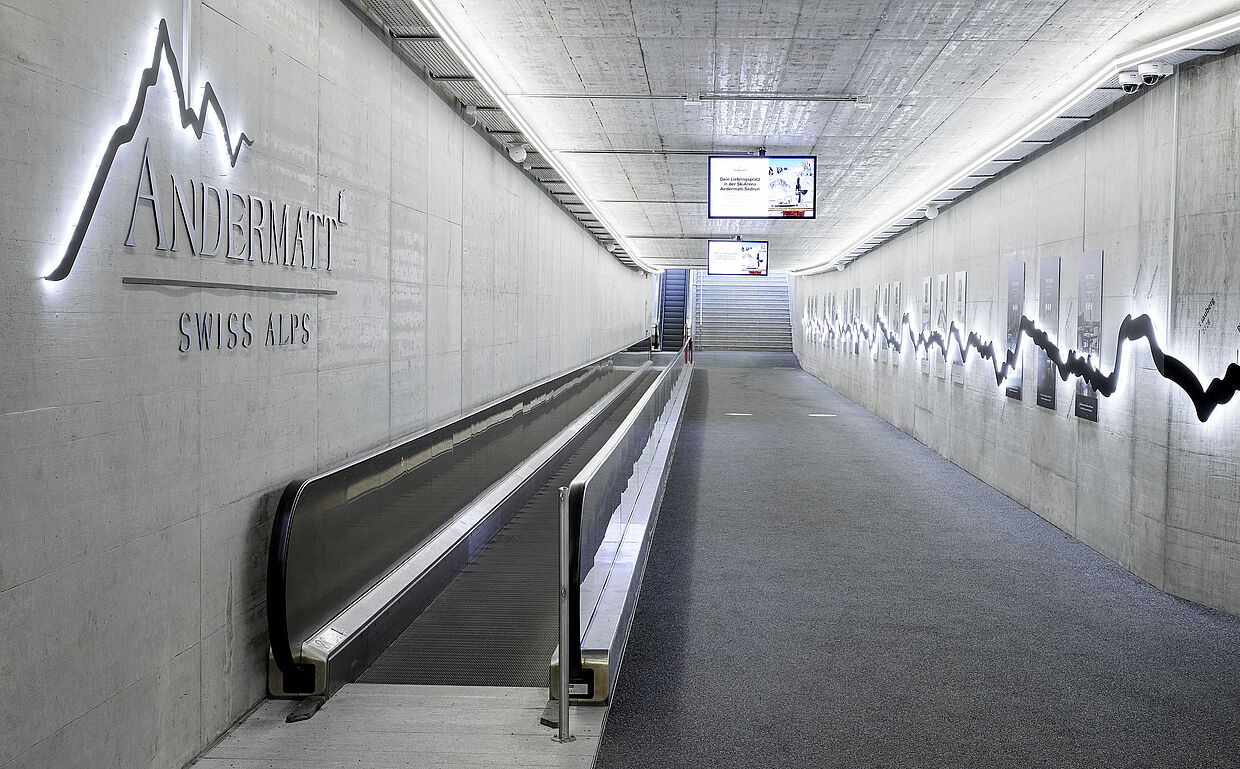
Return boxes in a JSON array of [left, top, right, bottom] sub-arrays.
[[787, 12, 1240, 277]]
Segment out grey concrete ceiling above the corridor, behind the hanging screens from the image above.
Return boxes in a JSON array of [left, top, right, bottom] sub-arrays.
[[424, 0, 1240, 270]]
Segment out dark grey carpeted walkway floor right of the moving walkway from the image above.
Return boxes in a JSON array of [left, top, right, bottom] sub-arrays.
[[595, 352, 1240, 769]]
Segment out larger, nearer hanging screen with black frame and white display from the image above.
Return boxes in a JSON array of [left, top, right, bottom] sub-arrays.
[[707, 155, 818, 220]]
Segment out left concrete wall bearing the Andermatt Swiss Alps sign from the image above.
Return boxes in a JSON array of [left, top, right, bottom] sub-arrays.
[[0, 0, 651, 768]]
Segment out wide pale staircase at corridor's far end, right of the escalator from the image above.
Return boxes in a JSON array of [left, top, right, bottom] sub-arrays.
[[694, 272, 792, 352]]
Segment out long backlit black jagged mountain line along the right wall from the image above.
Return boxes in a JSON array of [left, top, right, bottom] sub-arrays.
[[810, 313, 1240, 422]]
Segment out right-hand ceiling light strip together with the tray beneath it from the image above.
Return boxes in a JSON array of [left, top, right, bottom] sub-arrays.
[[789, 12, 1240, 277]]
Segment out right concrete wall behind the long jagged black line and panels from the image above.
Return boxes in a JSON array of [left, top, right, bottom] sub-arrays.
[[794, 56, 1240, 614]]
